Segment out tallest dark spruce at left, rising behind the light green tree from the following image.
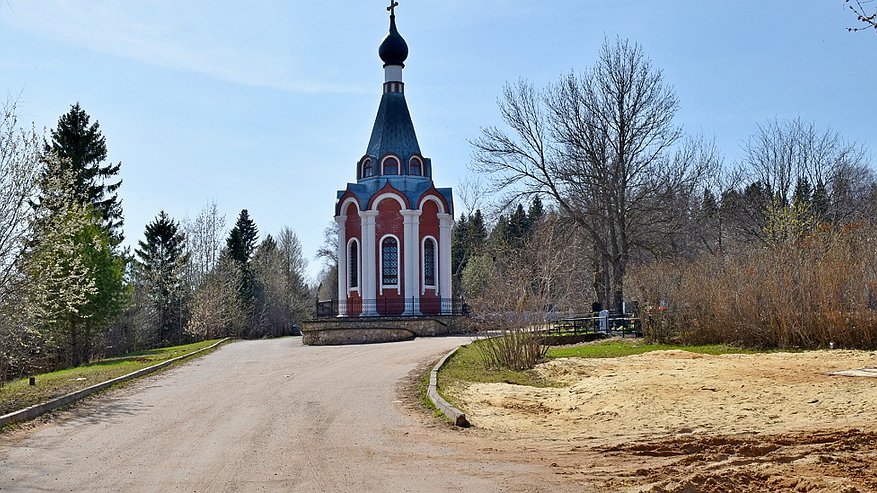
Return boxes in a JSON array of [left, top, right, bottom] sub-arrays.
[[39, 103, 123, 244]]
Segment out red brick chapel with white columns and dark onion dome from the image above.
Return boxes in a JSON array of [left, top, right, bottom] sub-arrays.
[[335, 2, 454, 317]]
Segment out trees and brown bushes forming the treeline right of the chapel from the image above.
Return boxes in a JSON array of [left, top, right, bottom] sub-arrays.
[[454, 39, 877, 347]]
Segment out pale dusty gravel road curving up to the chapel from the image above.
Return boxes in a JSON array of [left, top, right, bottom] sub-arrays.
[[0, 338, 568, 492]]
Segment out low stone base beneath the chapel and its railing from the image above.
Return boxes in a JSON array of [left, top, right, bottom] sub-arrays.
[[302, 317, 466, 346]]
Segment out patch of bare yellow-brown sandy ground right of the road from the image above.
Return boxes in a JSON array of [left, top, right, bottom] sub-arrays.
[[452, 351, 877, 493]]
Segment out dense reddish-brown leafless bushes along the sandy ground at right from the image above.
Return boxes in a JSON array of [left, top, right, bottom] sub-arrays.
[[630, 226, 877, 348]]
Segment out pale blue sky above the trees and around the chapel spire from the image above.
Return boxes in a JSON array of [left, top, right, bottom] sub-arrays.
[[0, 0, 877, 278]]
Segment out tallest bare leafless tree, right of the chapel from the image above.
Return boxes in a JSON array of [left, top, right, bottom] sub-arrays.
[[472, 39, 717, 309]]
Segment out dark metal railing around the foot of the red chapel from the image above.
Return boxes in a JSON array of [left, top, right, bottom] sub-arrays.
[[315, 297, 469, 318]]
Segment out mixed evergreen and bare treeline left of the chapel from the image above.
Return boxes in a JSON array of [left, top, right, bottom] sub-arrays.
[[0, 102, 311, 382]]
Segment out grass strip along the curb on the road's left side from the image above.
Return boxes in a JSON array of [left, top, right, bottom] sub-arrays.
[[0, 339, 226, 415]]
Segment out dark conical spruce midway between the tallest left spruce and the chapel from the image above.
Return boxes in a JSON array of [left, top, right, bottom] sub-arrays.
[[136, 211, 188, 344]]
